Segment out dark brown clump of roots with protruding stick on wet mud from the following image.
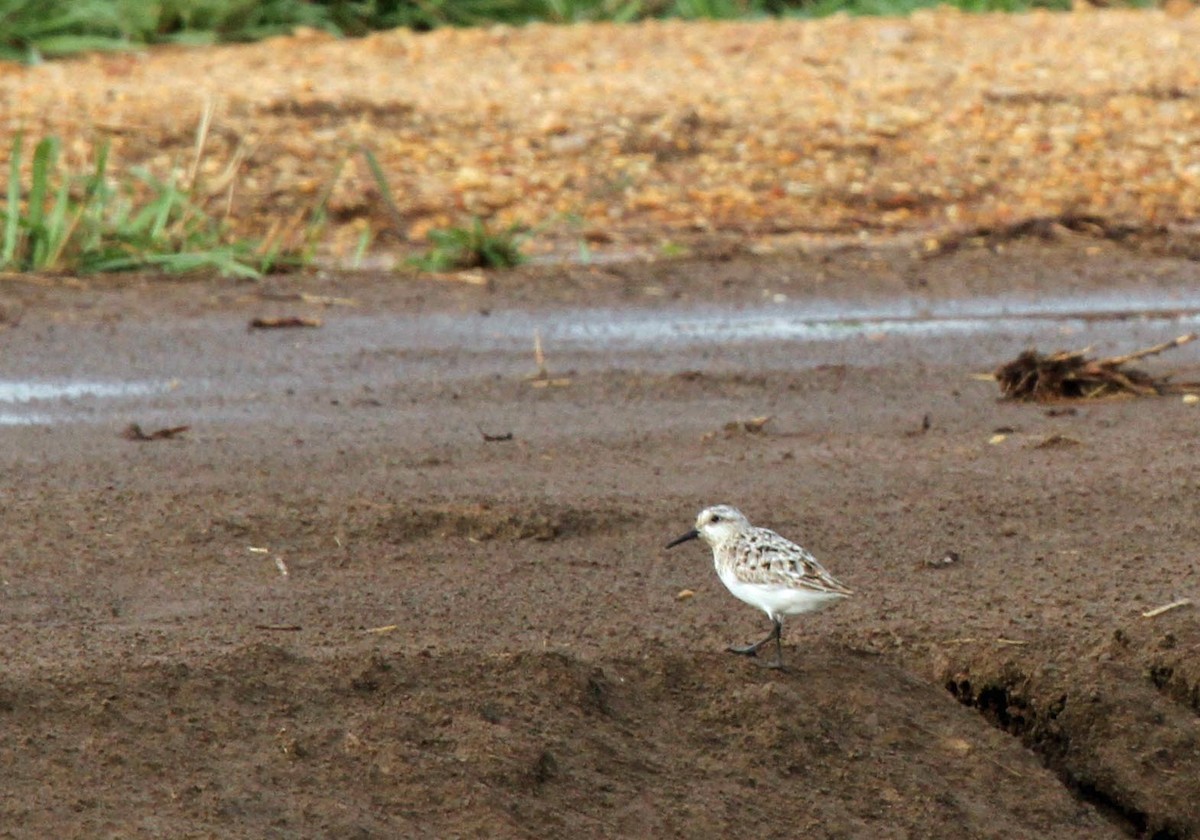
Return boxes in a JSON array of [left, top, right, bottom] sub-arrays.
[[992, 332, 1198, 402]]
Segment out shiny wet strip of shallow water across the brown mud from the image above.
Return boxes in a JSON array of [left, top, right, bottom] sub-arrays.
[[0, 292, 1200, 426]]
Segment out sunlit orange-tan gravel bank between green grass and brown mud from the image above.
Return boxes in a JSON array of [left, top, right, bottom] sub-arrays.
[[7, 8, 1200, 257]]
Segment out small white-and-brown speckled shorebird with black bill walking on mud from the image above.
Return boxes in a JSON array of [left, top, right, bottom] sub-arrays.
[[666, 504, 853, 668]]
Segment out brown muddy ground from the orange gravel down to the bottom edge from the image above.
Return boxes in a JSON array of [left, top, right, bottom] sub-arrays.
[[0, 241, 1200, 839]]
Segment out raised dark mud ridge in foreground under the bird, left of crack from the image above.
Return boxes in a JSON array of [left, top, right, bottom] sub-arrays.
[[0, 644, 1103, 839]]
